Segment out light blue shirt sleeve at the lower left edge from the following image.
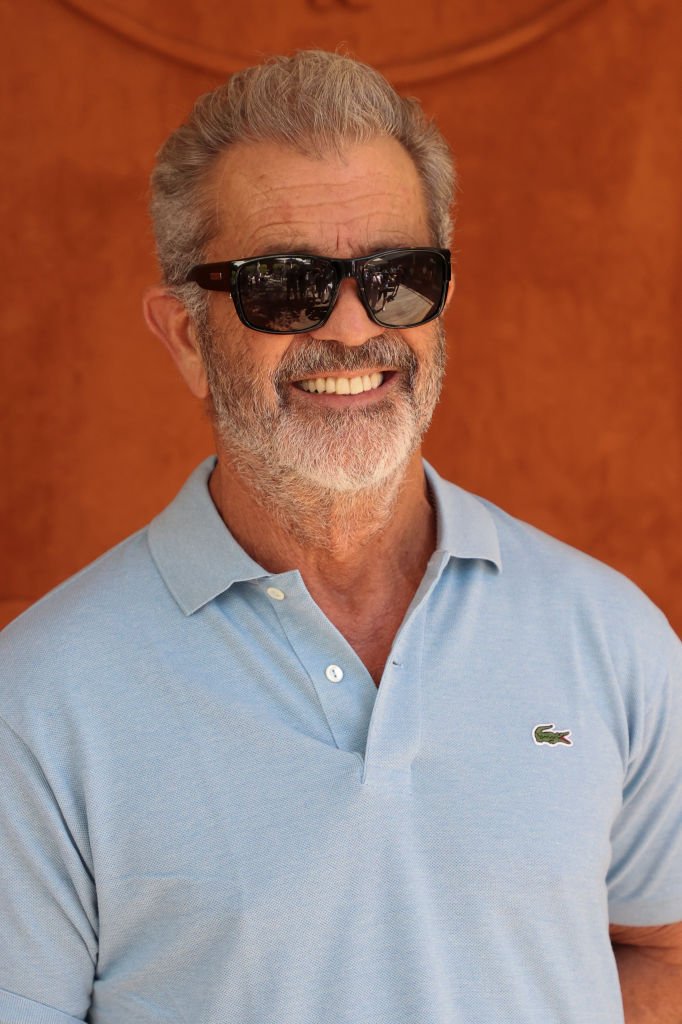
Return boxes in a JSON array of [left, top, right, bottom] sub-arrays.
[[0, 719, 97, 1024]]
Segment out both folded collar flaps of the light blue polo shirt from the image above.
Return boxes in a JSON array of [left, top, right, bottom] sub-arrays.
[[147, 456, 502, 615]]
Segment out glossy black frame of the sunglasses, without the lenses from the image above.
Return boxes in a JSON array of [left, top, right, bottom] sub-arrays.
[[186, 246, 452, 334]]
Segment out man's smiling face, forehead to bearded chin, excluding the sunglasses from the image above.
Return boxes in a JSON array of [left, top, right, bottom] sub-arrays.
[[192, 138, 444, 492]]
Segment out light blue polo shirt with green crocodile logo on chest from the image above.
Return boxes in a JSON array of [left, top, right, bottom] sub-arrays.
[[0, 460, 682, 1024]]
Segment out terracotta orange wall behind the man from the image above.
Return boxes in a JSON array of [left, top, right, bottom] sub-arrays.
[[0, 0, 682, 629]]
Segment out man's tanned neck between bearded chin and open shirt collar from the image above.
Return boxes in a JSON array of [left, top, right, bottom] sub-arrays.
[[204, 451, 435, 603]]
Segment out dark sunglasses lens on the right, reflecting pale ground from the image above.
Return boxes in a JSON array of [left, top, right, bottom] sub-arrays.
[[363, 250, 447, 327]]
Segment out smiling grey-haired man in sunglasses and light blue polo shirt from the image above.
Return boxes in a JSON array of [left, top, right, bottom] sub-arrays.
[[0, 52, 682, 1024]]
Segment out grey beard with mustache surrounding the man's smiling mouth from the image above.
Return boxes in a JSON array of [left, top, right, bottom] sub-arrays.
[[198, 321, 445, 545]]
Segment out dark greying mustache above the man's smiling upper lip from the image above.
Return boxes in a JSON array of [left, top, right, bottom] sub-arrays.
[[273, 334, 418, 387]]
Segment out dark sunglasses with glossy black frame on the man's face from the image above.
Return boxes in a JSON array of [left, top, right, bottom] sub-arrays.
[[187, 248, 451, 334]]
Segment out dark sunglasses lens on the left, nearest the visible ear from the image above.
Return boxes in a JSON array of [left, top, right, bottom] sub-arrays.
[[237, 256, 336, 334]]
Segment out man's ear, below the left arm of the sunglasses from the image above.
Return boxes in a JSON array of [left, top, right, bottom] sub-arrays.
[[142, 286, 209, 398]]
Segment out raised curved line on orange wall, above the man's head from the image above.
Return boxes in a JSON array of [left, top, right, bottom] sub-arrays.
[[60, 0, 605, 84]]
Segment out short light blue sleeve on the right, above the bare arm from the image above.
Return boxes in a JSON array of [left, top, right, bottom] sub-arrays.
[[607, 630, 682, 926]]
